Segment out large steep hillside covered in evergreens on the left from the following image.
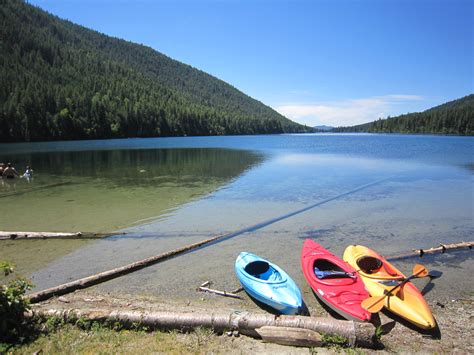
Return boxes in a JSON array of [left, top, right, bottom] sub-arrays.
[[0, 0, 311, 142]]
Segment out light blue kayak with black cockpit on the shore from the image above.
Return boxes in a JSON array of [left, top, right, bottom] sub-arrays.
[[235, 252, 303, 314]]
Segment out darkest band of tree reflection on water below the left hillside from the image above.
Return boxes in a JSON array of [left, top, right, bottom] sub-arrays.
[[0, 148, 261, 183]]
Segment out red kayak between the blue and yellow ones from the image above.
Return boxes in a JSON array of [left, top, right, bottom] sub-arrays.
[[301, 239, 371, 322]]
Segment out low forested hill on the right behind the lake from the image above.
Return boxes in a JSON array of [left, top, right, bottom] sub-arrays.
[[332, 94, 474, 136]]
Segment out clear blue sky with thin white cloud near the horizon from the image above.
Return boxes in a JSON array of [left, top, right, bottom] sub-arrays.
[[29, 0, 474, 126]]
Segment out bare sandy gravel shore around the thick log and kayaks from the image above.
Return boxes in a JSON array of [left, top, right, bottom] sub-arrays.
[[27, 290, 474, 354]]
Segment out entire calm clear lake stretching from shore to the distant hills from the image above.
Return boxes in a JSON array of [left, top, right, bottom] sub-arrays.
[[0, 134, 474, 299]]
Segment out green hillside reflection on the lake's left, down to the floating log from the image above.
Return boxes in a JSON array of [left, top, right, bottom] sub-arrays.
[[0, 149, 263, 231]]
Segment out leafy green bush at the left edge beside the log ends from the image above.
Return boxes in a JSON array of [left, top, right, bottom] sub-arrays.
[[0, 262, 32, 353]]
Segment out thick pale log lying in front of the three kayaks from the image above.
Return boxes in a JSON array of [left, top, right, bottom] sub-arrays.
[[30, 309, 376, 347]]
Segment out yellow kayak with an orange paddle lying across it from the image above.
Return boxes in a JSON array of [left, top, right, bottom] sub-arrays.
[[343, 245, 436, 329]]
